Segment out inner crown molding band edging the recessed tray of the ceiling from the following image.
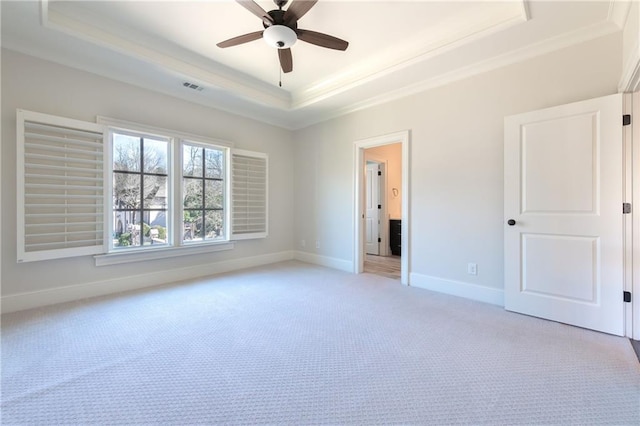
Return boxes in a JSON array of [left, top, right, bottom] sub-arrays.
[[41, 0, 529, 111]]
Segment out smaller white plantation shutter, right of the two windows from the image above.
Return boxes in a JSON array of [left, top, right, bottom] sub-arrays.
[[231, 150, 268, 240]]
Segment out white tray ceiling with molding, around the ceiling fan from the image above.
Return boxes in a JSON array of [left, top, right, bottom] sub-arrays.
[[1, 0, 629, 129]]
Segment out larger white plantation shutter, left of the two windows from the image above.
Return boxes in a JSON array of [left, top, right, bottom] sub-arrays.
[[17, 110, 105, 262]]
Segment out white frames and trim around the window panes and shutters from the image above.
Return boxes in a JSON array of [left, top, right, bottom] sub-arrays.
[[16, 113, 269, 266]]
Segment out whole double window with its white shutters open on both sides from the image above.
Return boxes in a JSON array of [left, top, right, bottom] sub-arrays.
[[17, 110, 268, 265]]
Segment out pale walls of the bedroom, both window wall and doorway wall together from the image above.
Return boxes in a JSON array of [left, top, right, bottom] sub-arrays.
[[1, 30, 622, 310]]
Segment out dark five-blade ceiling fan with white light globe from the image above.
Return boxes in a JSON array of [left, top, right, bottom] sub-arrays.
[[217, 0, 349, 73]]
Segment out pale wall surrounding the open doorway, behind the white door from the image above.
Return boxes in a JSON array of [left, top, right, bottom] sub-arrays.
[[294, 33, 622, 303]]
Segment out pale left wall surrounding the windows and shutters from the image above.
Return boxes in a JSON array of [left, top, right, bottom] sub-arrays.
[[1, 50, 293, 311]]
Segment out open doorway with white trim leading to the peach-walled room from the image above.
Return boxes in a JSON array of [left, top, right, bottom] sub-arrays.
[[353, 131, 411, 285]]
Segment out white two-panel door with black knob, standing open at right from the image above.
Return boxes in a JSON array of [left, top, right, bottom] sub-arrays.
[[504, 94, 624, 335]]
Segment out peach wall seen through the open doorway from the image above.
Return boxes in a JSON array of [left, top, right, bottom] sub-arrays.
[[364, 143, 402, 219]]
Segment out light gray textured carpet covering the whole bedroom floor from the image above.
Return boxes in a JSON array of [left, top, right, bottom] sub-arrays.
[[2, 262, 640, 425]]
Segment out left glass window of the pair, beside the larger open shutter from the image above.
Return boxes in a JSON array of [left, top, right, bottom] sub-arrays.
[[111, 132, 169, 248]]
